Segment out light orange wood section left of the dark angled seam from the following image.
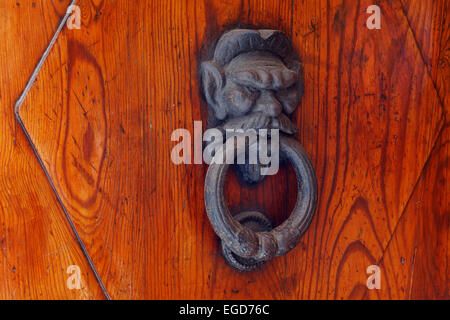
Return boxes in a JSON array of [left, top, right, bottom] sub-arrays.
[[0, 0, 104, 299]]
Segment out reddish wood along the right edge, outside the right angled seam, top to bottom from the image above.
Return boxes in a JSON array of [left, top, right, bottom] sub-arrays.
[[382, 0, 450, 299]]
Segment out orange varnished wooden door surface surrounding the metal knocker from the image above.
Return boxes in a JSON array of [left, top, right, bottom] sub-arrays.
[[4, 0, 450, 299]]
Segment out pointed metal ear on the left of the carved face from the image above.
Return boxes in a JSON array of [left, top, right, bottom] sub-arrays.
[[200, 61, 227, 120]]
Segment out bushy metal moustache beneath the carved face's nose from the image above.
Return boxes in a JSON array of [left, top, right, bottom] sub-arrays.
[[220, 112, 298, 134]]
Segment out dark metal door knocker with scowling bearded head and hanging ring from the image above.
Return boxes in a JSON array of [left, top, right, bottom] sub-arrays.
[[200, 29, 317, 271]]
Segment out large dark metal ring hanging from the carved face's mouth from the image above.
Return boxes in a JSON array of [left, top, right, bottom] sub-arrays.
[[205, 136, 317, 261]]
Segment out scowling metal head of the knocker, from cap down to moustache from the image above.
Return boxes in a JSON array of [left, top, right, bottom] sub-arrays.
[[201, 29, 303, 134]]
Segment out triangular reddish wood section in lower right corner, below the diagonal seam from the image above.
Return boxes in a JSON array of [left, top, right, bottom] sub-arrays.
[[380, 124, 450, 300]]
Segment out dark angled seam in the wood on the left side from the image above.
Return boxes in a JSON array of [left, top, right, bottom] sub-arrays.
[[14, 0, 111, 300]]
